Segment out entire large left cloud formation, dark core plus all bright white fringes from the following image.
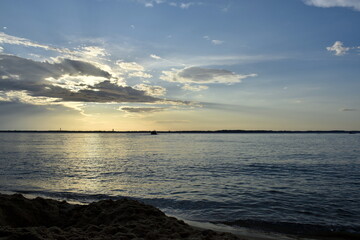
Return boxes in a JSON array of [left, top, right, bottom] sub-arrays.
[[0, 34, 195, 114]]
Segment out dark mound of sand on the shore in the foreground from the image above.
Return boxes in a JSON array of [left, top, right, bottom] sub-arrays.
[[0, 194, 242, 240]]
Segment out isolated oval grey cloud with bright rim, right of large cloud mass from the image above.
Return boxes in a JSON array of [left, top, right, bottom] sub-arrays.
[[160, 67, 257, 84]]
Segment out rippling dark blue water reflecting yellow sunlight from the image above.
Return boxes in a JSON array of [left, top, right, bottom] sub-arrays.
[[0, 133, 360, 233]]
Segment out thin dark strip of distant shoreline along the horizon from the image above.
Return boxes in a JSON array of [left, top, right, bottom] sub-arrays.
[[0, 130, 360, 134]]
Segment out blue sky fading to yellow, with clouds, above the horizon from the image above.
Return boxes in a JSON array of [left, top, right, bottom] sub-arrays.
[[0, 0, 360, 131]]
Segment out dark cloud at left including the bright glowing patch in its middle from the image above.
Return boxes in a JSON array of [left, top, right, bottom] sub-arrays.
[[0, 55, 161, 107]]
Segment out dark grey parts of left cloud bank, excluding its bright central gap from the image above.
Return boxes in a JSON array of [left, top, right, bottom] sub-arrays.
[[0, 54, 159, 103]]
